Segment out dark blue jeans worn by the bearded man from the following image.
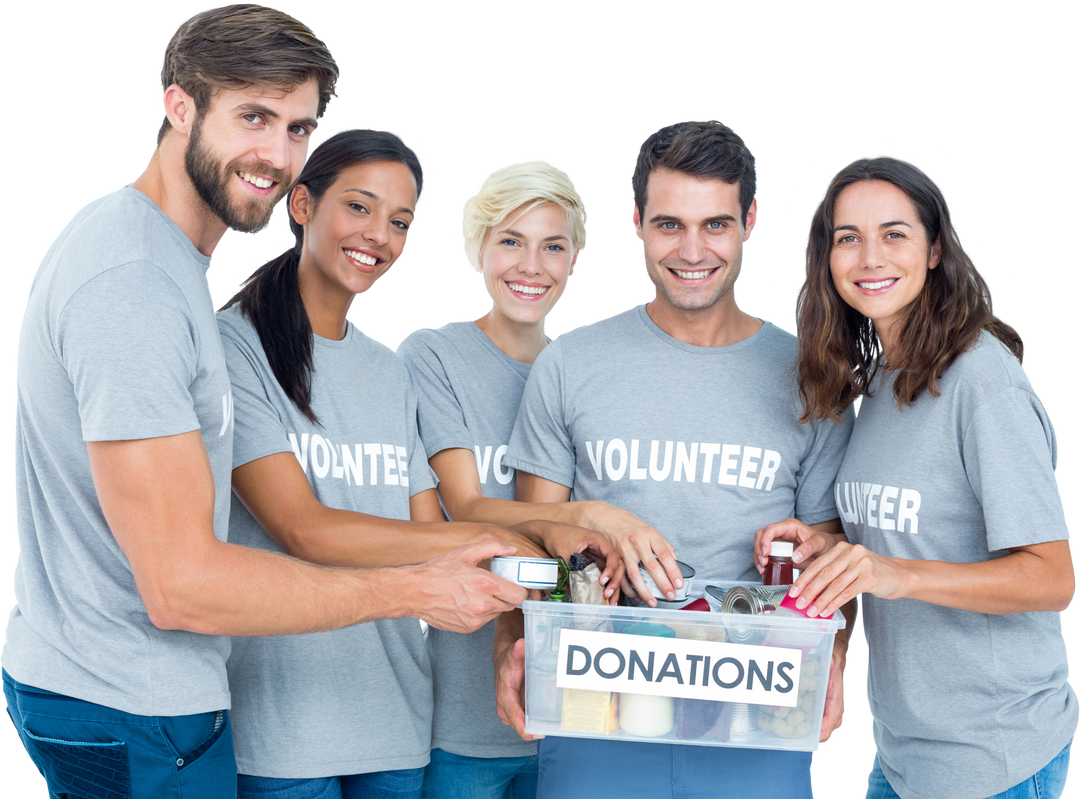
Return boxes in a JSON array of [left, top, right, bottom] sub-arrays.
[[0, 668, 237, 799]]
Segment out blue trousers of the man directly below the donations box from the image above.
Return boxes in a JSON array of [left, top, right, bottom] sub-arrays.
[[537, 735, 813, 799]]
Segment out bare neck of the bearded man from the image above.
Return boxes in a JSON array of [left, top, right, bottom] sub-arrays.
[[132, 130, 229, 255]]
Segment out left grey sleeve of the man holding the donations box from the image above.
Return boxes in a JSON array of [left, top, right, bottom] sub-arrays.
[[502, 342, 577, 489]]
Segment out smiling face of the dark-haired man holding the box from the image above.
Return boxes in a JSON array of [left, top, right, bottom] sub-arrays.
[[631, 168, 758, 311]]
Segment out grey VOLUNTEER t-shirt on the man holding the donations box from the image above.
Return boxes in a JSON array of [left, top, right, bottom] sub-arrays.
[[503, 302, 851, 582]]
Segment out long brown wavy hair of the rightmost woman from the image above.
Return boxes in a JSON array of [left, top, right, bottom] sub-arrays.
[[793, 152, 1027, 422]]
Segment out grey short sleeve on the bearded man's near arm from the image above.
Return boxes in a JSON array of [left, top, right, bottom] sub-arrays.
[[60, 262, 200, 442]]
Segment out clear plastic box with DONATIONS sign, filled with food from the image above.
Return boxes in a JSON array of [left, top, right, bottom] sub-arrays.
[[523, 578, 845, 751]]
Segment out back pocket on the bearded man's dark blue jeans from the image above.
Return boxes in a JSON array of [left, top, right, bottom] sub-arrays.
[[23, 729, 132, 799]]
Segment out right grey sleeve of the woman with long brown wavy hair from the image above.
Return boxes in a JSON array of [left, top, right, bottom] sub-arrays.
[[962, 387, 1072, 552]]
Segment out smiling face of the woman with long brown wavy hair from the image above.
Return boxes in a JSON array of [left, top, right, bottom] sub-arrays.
[[828, 180, 941, 349]]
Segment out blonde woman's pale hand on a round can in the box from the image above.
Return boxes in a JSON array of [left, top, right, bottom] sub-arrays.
[[576, 501, 683, 608]]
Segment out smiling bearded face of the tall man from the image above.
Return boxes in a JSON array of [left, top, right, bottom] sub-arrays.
[[184, 79, 319, 235]]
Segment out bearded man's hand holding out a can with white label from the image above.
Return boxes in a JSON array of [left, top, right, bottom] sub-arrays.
[[403, 540, 526, 633]]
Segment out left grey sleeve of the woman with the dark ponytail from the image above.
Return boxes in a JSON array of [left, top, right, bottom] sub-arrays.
[[218, 316, 293, 469]]
